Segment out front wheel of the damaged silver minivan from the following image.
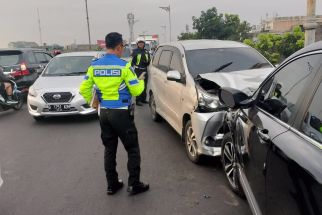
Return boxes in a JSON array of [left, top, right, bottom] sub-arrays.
[[184, 120, 200, 163]]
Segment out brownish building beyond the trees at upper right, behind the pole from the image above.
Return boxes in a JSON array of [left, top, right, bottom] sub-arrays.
[[260, 15, 322, 41]]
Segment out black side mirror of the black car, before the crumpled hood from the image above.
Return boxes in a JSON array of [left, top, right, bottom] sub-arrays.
[[219, 87, 255, 109]]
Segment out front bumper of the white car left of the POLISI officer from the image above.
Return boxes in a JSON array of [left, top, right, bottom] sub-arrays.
[[27, 95, 97, 117]]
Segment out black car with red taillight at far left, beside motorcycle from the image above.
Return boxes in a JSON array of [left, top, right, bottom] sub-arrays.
[[0, 48, 52, 91]]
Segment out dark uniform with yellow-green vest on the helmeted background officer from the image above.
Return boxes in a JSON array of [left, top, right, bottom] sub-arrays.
[[132, 48, 151, 102]]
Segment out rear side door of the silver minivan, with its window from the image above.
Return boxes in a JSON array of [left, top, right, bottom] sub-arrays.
[[153, 47, 173, 117]]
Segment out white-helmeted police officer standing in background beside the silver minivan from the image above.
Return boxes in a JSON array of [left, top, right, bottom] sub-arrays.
[[132, 37, 151, 106]]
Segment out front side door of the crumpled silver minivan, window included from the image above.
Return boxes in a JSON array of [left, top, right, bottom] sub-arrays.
[[164, 48, 185, 131]]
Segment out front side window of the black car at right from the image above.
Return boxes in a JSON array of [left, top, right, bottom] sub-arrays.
[[258, 54, 322, 125]]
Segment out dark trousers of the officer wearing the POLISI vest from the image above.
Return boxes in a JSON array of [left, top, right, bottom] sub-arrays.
[[100, 109, 141, 186]]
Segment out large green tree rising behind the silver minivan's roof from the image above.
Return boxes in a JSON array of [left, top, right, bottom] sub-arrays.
[[178, 7, 251, 41]]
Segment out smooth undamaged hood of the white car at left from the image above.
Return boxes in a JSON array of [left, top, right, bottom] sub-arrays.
[[33, 75, 84, 91]]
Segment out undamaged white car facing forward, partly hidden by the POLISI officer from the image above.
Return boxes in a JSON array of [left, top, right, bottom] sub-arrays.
[[27, 52, 103, 120]]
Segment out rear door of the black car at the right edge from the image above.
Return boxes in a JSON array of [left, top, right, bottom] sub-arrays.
[[266, 63, 322, 215]]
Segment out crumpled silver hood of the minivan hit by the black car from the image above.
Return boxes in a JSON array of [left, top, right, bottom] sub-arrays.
[[199, 68, 274, 95]]
